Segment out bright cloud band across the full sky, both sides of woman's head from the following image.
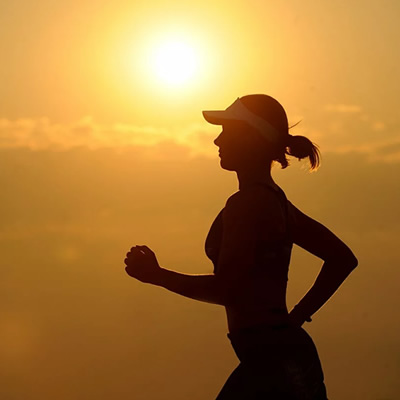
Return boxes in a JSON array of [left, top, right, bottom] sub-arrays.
[[0, 114, 400, 162]]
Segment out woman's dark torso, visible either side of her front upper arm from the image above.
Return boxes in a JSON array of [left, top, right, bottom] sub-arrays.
[[205, 184, 293, 332]]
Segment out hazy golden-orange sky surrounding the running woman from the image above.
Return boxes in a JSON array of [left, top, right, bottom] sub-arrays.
[[0, 0, 400, 400]]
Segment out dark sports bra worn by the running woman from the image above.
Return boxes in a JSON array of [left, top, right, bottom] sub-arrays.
[[205, 182, 293, 281]]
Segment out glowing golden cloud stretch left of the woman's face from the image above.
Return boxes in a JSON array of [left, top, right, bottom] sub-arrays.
[[0, 116, 216, 156]]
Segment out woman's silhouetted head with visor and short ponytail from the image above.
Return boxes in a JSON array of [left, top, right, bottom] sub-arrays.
[[203, 94, 319, 171]]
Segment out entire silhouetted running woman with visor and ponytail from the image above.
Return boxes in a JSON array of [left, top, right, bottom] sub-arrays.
[[125, 94, 357, 400]]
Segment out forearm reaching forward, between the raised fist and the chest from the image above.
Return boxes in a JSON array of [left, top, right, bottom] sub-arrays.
[[154, 268, 225, 305]]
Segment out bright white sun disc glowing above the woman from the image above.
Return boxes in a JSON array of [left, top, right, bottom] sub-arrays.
[[151, 40, 199, 86]]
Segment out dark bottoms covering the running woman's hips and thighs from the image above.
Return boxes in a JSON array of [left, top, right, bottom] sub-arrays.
[[216, 325, 328, 400]]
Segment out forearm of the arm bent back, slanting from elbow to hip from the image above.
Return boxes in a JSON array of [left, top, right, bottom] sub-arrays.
[[290, 260, 357, 321]]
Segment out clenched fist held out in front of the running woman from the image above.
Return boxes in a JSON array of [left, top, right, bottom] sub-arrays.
[[124, 246, 161, 283]]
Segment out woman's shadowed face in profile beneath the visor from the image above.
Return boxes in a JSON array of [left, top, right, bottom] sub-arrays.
[[214, 121, 267, 171]]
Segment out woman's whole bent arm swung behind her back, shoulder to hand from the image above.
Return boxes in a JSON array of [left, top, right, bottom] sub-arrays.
[[289, 203, 358, 326]]
